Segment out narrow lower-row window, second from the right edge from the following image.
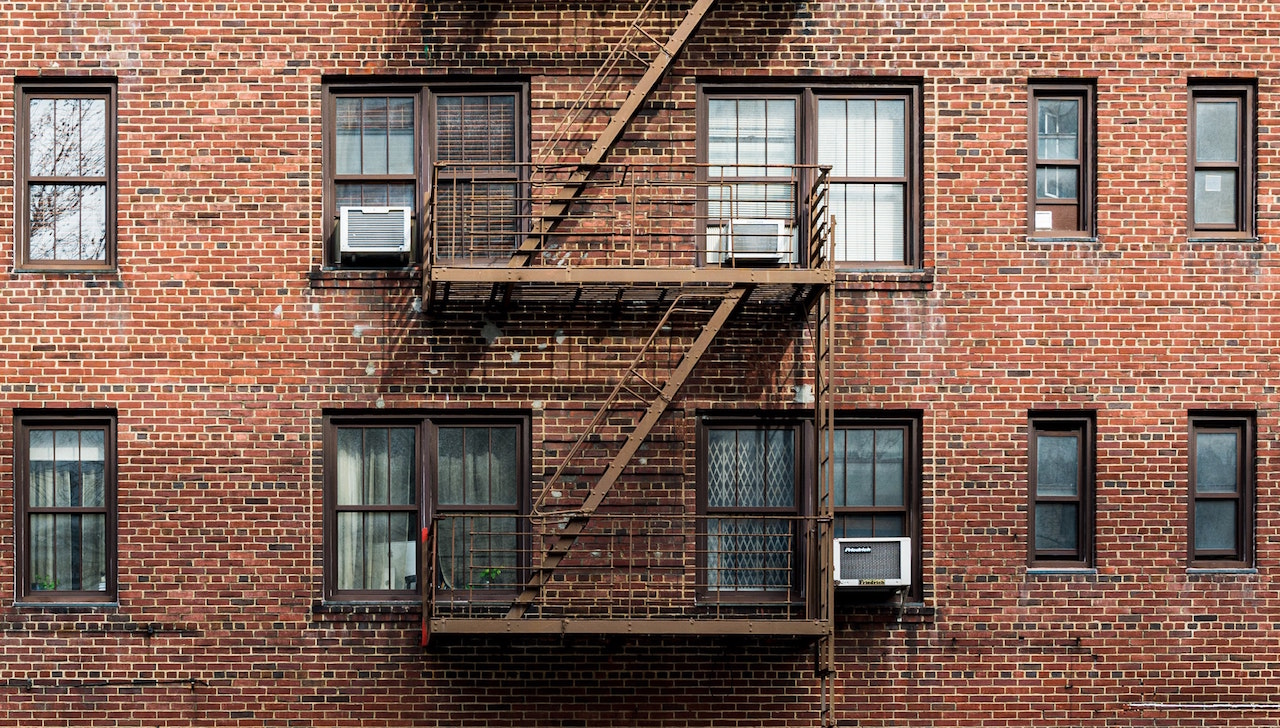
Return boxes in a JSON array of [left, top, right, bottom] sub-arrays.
[[1027, 415, 1093, 568]]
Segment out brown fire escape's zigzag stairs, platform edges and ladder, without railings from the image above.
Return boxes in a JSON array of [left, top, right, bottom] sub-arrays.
[[424, 0, 835, 644]]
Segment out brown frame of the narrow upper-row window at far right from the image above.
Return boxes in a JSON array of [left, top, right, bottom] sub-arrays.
[[1187, 82, 1257, 239]]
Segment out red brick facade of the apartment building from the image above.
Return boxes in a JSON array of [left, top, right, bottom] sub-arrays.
[[0, 0, 1280, 728]]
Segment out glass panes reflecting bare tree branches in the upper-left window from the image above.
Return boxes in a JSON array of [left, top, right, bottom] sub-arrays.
[[27, 99, 108, 261]]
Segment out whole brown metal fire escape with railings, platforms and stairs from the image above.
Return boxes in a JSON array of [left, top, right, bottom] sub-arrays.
[[422, 0, 835, 665]]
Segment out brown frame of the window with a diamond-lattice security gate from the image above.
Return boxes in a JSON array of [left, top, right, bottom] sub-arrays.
[[695, 415, 817, 605]]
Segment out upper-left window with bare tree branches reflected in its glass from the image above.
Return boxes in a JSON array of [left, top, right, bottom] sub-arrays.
[[17, 83, 115, 270]]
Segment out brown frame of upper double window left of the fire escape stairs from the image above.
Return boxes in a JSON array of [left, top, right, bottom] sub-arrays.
[[321, 79, 530, 270]]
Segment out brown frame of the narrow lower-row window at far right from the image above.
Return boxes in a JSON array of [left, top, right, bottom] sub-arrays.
[[1187, 412, 1257, 568]]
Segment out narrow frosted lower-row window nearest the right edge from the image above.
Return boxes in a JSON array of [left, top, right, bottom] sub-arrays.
[[1188, 413, 1253, 567]]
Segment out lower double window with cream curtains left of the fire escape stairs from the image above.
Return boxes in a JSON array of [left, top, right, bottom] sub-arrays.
[[325, 416, 529, 600]]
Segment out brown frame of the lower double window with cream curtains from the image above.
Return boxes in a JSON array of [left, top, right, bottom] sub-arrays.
[[323, 412, 532, 603]]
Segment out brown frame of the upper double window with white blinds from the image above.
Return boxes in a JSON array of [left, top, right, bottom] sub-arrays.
[[696, 79, 924, 271]]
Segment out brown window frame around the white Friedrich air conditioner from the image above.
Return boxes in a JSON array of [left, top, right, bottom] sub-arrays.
[[832, 412, 924, 599]]
